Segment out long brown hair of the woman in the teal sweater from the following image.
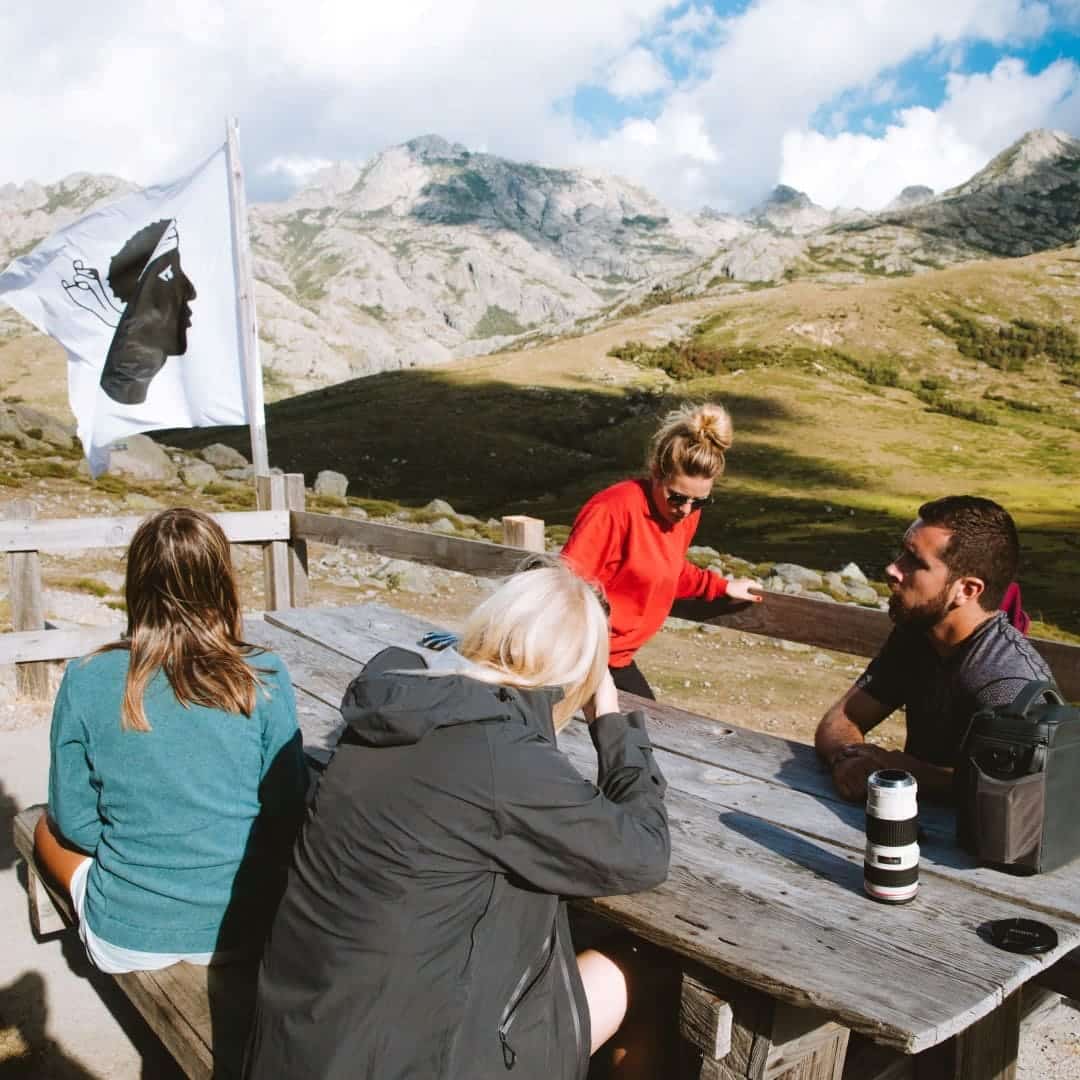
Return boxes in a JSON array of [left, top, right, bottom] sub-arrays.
[[110, 508, 259, 731]]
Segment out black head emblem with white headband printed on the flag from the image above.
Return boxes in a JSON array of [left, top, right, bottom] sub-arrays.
[[62, 220, 195, 405]]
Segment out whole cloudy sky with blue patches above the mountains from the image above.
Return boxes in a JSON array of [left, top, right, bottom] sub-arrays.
[[6, 0, 1080, 211]]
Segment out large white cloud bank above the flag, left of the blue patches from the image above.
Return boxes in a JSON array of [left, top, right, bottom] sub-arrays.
[[0, 0, 671, 192]]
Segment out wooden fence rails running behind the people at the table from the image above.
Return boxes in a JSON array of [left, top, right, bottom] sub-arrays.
[[0, 503, 1080, 701]]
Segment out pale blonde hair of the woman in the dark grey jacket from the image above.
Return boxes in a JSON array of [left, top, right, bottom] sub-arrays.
[[458, 565, 608, 730]]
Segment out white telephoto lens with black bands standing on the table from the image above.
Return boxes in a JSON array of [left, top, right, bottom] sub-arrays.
[[863, 769, 919, 904]]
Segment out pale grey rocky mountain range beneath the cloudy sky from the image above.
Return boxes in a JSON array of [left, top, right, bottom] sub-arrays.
[[0, 131, 1080, 399]]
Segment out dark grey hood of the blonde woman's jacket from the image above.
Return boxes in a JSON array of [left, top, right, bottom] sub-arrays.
[[341, 647, 563, 747]]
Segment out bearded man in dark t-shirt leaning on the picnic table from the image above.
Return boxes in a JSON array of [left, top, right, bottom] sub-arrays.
[[814, 495, 1053, 799]]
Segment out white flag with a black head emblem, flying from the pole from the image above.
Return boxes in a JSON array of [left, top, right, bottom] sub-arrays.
[[0, 146, 261, 476]]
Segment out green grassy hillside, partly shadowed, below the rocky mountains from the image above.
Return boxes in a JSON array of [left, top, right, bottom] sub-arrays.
[[8, 249, 1080, 633]]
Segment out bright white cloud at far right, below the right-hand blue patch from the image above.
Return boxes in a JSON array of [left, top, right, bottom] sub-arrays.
[[780, 58, 1080, 210]]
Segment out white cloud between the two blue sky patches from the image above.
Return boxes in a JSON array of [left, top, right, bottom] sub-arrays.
[[579, 0, 1047, 206]]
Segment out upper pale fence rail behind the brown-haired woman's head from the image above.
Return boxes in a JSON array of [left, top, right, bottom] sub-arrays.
[[0, 510, 289, 553]]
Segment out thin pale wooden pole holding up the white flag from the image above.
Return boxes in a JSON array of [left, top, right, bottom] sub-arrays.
[[225, 119, 270, 476]]
